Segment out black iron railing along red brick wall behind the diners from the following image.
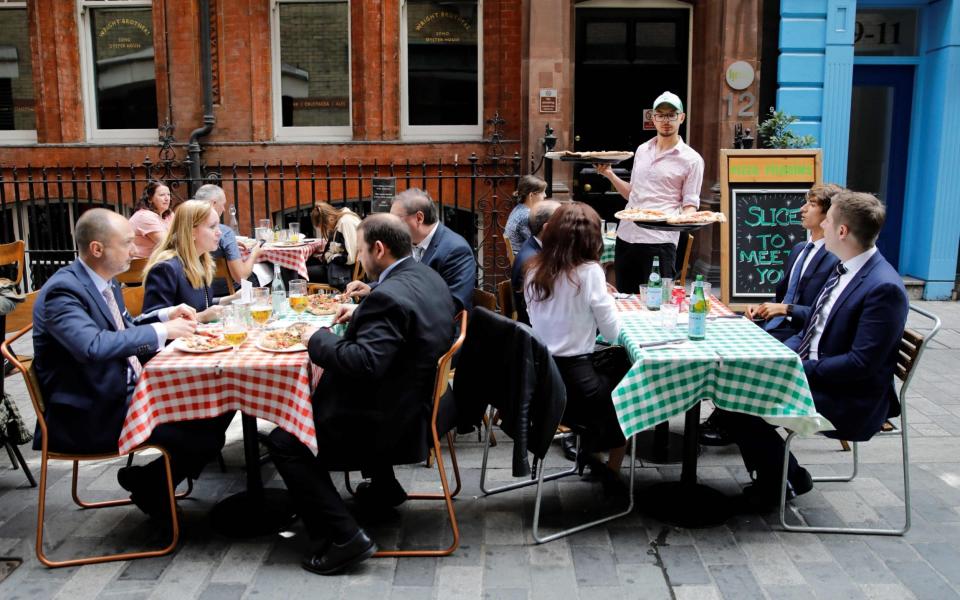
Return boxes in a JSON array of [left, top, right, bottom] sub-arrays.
[[0, 154, 521, 291]]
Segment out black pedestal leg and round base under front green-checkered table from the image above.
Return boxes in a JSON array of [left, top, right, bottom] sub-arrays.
[[641, 402, 734, 528]]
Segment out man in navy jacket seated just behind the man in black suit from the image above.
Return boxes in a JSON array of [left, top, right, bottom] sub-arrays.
[[390, 188, 477, 311]]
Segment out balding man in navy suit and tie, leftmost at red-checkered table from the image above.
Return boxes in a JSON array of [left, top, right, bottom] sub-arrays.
[[33, 208, 229, 517]]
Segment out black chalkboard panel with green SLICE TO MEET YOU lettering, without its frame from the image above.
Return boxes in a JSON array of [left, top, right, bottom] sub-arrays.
[[729, 188, 807, 299]]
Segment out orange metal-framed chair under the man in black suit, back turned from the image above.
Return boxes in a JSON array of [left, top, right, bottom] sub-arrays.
[[345, 310, 467, 558]]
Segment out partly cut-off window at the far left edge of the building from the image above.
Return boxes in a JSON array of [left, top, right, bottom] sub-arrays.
[[0, 2, 37, 144]]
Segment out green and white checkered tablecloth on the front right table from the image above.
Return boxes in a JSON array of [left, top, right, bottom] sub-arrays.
[[613, 312, 833, 438]]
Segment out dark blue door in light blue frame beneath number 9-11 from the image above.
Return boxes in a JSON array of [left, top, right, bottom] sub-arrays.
[[847, 65, 914, 267]]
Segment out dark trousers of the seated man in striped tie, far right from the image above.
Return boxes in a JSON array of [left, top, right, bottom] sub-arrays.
[[714, 409, 800, 486]]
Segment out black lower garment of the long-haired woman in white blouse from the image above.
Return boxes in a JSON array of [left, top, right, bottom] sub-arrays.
[[554, 355, 627, 452]]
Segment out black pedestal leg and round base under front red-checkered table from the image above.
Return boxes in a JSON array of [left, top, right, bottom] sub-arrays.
[[210, 413, 296, 538]]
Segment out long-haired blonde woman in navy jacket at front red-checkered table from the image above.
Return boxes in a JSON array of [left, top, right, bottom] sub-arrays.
[[143, 200, 230, 323]]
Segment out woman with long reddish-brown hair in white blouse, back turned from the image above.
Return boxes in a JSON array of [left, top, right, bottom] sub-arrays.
[[523, 202, 626, 488]]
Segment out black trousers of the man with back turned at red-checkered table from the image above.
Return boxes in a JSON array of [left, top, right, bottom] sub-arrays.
[[268, 427, 394, 544]]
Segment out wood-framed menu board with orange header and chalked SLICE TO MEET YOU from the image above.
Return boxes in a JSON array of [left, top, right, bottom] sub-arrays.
[[720, 149, 823, 311]]
